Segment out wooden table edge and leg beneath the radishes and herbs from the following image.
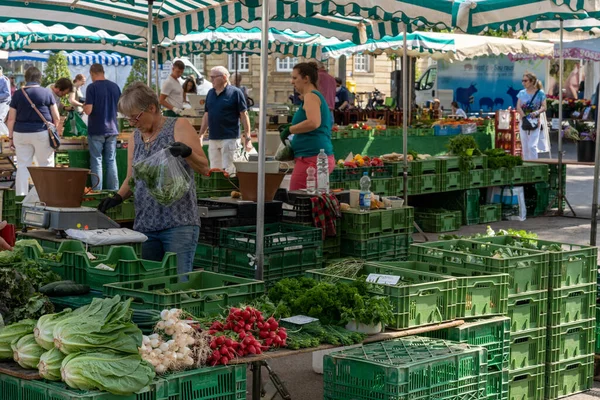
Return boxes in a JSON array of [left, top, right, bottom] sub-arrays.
[[230, 320, 465, 400]]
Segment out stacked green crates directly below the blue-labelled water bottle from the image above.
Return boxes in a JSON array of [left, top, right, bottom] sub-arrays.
[[339, 207, 414, 261]]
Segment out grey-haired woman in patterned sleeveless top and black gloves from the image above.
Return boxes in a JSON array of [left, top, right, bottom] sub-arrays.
[[98, 82, 208, 274]]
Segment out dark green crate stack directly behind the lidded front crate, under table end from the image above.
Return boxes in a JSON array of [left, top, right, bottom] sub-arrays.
[[422, 316, 510, 400]]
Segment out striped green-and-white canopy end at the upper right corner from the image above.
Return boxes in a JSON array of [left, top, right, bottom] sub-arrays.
[[453, 0, 592, 34]]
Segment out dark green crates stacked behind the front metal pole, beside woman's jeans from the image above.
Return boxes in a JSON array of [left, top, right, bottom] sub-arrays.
[[219, 223, 323, 286]]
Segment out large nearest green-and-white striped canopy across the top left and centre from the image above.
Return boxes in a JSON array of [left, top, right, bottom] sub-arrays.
[[0, 0, 454, 44]]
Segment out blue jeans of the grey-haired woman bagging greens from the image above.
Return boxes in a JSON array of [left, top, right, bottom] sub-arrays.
[[142, 225, 200, 274]]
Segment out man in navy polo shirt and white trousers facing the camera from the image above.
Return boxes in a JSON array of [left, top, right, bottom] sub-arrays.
[[200, 67, 253, 173]]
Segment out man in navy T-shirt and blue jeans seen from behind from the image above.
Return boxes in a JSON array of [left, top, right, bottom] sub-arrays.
[[83, 64, 121, 191]]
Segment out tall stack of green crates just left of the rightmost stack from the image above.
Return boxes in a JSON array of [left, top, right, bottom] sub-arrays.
[[410, 238, 549, 400]]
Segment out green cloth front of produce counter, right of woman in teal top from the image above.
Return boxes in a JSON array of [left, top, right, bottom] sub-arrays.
[[331, 129, 494, 160]]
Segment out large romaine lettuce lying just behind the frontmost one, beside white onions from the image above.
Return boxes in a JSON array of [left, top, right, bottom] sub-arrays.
[[53, 296, 142, 354]]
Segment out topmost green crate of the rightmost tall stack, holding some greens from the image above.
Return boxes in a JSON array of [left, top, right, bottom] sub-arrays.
[[473, 236, 598, 290]]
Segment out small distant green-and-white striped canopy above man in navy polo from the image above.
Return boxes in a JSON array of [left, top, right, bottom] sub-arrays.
[[161, 28, 342, 60]]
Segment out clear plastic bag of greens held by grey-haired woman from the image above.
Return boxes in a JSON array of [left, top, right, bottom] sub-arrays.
[[133, 147, 190, 206]]
